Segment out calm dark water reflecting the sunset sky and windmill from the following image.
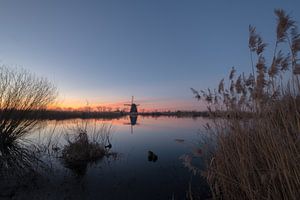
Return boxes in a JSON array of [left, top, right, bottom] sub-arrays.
[[5, 116, 209, 199]]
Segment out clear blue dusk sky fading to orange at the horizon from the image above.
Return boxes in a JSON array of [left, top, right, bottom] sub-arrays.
[[0, 0, 300, 110]]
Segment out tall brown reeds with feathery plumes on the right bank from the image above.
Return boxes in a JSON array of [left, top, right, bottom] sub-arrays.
[[193, 9, 300, 199]]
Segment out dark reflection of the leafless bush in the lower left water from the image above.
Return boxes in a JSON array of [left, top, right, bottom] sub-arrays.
[[0, 142, 48, 199]]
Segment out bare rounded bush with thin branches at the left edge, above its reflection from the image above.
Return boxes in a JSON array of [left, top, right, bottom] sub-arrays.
[[0, 66, 57, 147]]
